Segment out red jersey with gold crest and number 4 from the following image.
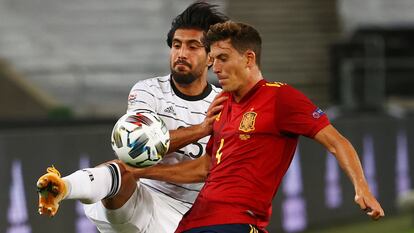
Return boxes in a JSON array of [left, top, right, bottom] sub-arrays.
[[176, 80, 329, 232]]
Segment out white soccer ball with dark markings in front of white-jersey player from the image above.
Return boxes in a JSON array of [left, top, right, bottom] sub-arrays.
[[111, 113, 170, 167]]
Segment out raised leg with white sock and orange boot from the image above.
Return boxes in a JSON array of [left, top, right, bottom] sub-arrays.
[[37, 161, 136, 217]]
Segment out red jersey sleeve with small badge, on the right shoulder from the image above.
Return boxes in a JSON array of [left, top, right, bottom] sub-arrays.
[[277, 85, 330, 138]]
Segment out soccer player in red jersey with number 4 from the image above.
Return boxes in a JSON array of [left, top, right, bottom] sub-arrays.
[[130, 21, 384, 233]]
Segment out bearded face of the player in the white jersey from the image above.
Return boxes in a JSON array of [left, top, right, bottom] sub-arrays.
[[170, 29, 208, 84]]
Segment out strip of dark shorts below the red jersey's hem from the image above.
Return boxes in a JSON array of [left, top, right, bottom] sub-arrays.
[[183, 224, 263, 233]]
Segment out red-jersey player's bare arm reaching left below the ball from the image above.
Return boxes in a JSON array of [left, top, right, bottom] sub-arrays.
[[127, 154, 211, 183]]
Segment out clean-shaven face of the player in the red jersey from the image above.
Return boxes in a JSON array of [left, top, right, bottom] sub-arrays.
[[210, 39, 249, 92]]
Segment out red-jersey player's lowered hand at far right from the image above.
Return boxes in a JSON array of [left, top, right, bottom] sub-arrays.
[[355, 190, 385, 220]]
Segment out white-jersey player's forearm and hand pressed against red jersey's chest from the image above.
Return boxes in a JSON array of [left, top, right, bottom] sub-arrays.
[[167, 93, 227, 153]]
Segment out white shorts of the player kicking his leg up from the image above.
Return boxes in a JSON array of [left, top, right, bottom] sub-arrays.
[[84, 183, 189, 233]]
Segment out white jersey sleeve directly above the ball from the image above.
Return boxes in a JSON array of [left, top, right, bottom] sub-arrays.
[[127, 81, 157, 113]]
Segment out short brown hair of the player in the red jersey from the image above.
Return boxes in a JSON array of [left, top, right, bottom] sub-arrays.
[[206, 21, 262, 67]]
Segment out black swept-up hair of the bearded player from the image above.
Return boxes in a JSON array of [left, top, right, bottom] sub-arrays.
[[167, 1, 228, 52]]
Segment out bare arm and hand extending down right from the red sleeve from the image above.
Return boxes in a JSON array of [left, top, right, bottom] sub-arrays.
[[315, 125, 384, 220]]
